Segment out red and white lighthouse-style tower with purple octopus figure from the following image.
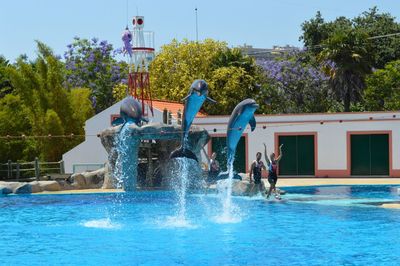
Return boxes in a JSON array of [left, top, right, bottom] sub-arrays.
[[122, 16, 154, 116]]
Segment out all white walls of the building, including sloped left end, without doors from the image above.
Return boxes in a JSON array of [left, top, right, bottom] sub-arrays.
[[63, 103, 400, 177]]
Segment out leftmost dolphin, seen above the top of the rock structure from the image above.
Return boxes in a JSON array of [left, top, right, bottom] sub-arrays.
[[112, 96, 149, 126]]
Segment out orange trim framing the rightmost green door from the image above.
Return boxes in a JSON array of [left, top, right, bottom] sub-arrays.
[[346, 130, 400, 177]]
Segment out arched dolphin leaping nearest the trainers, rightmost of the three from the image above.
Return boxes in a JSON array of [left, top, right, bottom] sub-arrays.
[[226, 99, 259, 166]]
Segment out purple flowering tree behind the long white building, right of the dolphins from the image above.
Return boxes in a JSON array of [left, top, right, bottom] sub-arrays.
[[257, 52, 335, 113]]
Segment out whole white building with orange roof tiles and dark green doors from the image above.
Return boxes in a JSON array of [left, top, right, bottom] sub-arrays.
[[63, 105, 400, 177]]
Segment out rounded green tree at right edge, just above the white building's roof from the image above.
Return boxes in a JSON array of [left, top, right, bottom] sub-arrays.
[[364, 60, 400, 111]]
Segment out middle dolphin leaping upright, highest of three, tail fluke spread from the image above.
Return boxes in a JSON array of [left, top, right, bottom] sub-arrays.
[[170, 79, 216, 161]]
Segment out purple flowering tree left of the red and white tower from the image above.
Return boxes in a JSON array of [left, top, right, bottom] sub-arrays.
[[64, 37, 127, 113]]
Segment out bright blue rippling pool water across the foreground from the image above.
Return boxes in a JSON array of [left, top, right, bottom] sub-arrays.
[[0, 186, 400, 265]]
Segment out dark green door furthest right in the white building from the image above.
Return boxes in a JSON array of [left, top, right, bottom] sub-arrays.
[[350, 134, 389, 175]]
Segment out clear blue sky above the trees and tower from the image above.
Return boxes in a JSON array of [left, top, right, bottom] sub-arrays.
[[0, 0, 400, 61]]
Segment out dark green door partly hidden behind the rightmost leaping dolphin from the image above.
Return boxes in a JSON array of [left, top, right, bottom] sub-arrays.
[[211, 136, 246, 173]]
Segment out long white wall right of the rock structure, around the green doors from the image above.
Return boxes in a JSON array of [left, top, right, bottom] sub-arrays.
[[195, 112, 400, 177]]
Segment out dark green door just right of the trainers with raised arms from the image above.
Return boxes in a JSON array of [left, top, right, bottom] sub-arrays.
[[279, 135, 315, 175]]
